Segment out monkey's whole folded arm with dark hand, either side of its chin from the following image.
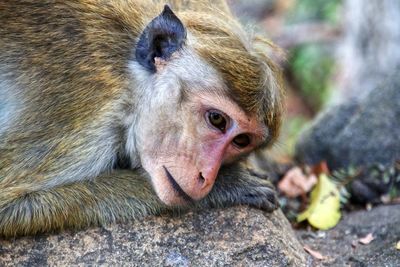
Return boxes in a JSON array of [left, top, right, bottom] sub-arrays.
[[0, 166, 277, 237]]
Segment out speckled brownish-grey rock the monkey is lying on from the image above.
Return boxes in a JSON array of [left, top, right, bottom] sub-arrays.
[[0, 207, 310, 266]]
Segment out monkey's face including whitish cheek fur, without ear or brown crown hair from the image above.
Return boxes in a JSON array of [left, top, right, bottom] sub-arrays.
[[129, 51, 267, 205]]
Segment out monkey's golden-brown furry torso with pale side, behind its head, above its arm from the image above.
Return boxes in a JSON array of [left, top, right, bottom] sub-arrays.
[[0, 0, 146, 181]]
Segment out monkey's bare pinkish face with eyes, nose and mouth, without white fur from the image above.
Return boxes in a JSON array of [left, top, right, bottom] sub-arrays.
[[139, 94, 265, 205]]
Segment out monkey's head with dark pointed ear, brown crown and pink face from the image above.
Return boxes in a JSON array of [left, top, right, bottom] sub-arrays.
[[126, 6, 281, 205]]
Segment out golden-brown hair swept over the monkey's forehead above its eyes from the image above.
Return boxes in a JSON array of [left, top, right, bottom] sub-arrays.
[[192, 37, 282, 137]]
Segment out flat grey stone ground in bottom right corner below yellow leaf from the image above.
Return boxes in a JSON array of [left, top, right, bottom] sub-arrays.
[[297, 205, 400, 266]]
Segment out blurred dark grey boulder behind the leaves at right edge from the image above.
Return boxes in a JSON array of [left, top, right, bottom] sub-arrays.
[[296, 72, 400, 169]]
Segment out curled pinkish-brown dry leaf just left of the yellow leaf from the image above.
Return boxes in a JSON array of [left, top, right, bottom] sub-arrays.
[[278, 167, 317, 198]]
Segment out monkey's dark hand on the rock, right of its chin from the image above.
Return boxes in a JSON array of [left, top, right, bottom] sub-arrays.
[[198, 164, 278, 211]]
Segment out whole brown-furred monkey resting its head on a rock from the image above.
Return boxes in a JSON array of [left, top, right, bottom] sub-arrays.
[[0, 0, 283, 238]]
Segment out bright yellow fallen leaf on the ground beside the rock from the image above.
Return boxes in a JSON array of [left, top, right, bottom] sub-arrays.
[[297, 173, 340, 230]]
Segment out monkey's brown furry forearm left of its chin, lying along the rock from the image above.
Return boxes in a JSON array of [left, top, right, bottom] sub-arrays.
[[0, 170, 167, 237]]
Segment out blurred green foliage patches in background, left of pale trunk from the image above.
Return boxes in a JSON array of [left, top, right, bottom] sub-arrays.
[[285, 0, 341, 113]]
